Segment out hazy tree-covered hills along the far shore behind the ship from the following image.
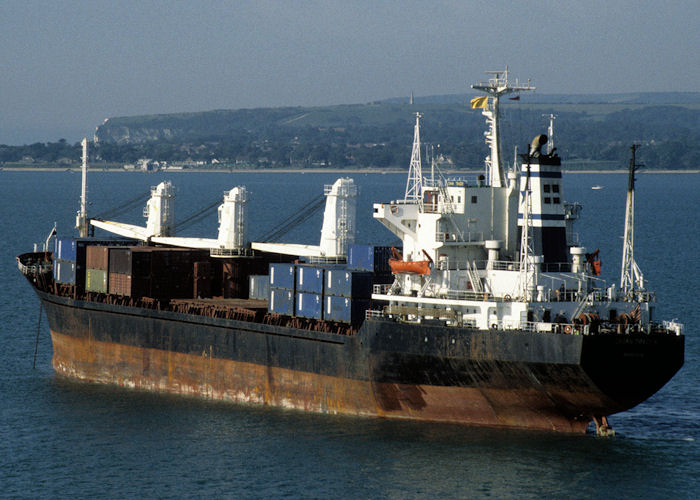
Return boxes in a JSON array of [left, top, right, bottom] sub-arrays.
[[0, 92, 700, 170]]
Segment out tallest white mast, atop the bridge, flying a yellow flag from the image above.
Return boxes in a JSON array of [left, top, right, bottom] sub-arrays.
[[471, 66, 535, 187]]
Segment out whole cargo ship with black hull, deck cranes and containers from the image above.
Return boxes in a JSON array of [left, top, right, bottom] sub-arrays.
[[17, 70, 685, 435]]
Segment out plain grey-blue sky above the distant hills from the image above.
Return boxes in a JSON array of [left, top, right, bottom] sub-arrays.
[[0, 0, 700, 145]]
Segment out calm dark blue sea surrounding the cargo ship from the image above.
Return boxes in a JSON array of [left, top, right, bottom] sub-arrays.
[[0, 171, 700, 499]]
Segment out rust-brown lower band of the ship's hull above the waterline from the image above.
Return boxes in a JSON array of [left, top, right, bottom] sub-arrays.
[[51, 331, 588, 433]]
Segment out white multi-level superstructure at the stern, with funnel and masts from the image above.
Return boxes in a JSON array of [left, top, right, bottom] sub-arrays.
[[372, 70, 676, 333]]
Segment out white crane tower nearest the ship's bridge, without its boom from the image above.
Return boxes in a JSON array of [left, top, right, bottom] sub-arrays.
[[320, 178, 357, 258]]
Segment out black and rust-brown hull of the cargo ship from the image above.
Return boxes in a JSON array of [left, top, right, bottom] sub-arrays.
[[38, 292, 683, 433]]
